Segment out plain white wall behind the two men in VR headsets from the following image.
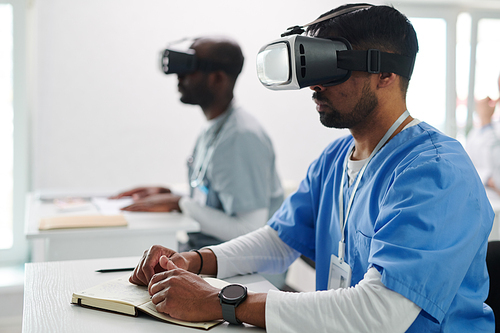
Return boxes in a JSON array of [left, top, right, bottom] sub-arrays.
[[30, 0, 364, 190]]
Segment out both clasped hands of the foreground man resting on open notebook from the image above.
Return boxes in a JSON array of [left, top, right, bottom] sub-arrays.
[[129, 245, 222, 322]]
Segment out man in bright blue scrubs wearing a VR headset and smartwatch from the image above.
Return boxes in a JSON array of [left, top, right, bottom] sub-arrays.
[[130, 4, 495, 332]]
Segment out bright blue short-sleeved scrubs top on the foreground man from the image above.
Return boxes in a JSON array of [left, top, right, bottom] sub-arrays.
[[269, 123, 494, 332]]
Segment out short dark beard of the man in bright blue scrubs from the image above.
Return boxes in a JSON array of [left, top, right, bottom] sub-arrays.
[[313, 82, 378, 128]]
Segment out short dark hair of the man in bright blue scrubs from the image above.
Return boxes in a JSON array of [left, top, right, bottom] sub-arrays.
[[307, 3, 418, 93]]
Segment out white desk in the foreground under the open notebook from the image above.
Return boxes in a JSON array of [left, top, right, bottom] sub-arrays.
[[22, 257, 276, 333]]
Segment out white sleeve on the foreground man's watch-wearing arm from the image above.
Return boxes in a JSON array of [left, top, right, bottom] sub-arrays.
[[266, 268, 421, 333]]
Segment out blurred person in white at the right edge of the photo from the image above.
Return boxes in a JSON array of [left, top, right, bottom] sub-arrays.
[[466, 77, 500, 194]]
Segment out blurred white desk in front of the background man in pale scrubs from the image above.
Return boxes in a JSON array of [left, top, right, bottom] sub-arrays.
[[25, 193, 200, 262]]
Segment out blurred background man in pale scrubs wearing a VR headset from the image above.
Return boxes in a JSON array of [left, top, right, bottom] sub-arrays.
[[115, 37, 283, 249]]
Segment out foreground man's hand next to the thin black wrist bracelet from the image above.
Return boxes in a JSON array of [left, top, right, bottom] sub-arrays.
[[129, 245, 189, 286]]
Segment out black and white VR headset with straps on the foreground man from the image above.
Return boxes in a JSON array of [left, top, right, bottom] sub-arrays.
[[257, 5, 415, 90]]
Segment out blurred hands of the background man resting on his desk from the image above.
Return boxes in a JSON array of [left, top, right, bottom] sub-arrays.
[[110, 187, 181, 212]]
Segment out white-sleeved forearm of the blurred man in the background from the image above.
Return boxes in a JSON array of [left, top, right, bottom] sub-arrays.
[[179, 197, 269, 241]]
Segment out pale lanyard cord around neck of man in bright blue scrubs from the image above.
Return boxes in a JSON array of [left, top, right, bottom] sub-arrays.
[[338, 110, 410, 263]]
